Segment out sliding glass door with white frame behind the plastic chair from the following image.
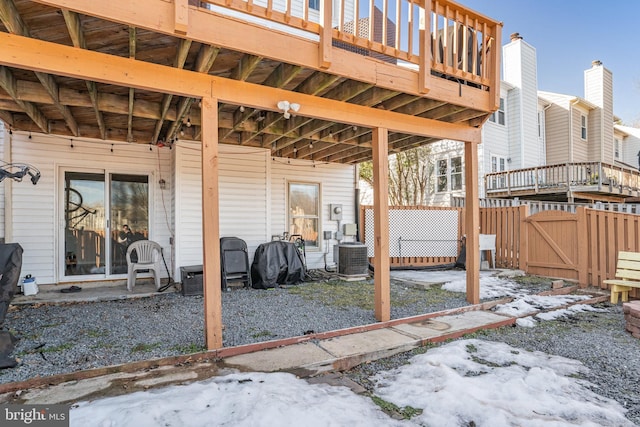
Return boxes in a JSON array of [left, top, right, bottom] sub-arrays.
[[61, 170, 149, 279]]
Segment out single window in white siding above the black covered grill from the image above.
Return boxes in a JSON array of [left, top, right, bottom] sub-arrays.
[[289, 182, 320, 248]]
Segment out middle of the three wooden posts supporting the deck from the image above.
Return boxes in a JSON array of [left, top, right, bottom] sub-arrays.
[[371, 128, 391, 322]]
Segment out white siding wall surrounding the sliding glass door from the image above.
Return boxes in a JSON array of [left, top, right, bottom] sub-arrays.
[[6, 132, 172, 284]]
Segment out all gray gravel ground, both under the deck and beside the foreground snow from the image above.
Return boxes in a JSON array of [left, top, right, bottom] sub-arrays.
[[0, 272, 640, 424]]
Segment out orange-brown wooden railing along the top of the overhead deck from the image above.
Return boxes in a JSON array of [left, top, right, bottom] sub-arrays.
[[200, 0, 502, 93]]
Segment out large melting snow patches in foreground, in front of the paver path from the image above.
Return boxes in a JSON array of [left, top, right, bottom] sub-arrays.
[[70, 340, 633, 427]]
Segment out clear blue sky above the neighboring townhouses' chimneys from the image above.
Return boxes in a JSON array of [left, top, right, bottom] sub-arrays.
[[458, 0, 640, 125]]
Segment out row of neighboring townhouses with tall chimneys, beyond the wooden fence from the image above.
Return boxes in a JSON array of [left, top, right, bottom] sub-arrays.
[[428, 33, 640, 206]]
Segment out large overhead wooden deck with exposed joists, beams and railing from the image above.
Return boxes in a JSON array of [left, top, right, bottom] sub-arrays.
[[0, 0, 501, 163]]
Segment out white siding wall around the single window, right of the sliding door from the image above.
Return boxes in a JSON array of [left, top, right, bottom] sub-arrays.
[[174, 141, 355, 277]]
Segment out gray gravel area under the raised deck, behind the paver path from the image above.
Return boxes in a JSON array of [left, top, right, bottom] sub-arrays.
[[0, 281, 467, 383]]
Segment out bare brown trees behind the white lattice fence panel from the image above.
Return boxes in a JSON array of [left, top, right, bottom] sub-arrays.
[[360, 146, 433, 206]]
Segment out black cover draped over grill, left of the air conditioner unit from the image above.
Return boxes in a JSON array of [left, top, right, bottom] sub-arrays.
[[251, 241, 305, 289]]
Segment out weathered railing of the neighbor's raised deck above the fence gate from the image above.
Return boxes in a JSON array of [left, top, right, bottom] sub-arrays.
[[484, 162, 640, 194]]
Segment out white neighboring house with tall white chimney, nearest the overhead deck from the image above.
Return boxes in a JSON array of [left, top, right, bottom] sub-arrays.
[[422, 33, 546, 206]]
